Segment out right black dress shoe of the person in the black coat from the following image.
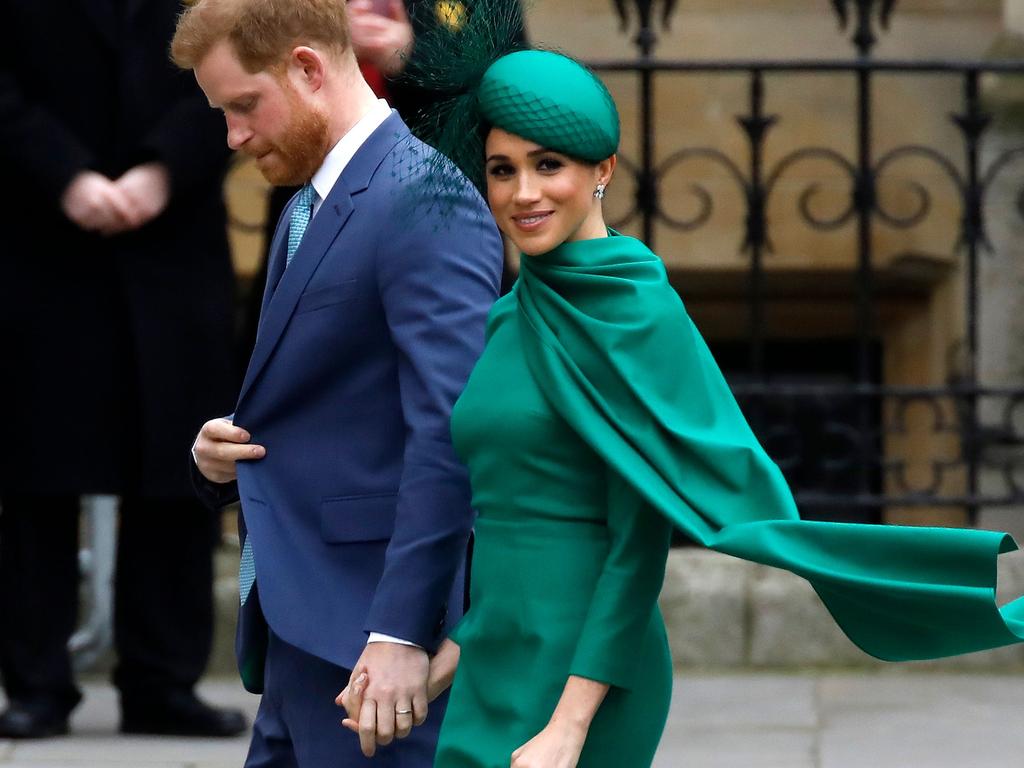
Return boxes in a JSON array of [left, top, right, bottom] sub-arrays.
[[121, 691, 249, 737]]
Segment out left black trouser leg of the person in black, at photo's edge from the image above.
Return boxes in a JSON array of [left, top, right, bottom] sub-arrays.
[[0, 496, 81, 712]]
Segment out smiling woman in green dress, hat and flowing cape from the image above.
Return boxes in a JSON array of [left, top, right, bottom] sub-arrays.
[[347, 40, 1024, 768]]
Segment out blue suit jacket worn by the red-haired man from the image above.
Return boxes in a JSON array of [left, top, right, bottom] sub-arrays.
[[195, 113, 502, 687]]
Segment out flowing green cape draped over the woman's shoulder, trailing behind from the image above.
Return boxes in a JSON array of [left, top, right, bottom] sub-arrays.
[[516, 232, 1024, 662]]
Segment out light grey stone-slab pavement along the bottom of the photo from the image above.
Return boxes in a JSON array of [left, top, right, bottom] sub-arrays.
[[0, 667, 1024, 768]]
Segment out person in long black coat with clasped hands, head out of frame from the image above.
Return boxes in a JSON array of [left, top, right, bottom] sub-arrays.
[[0, 0, 246, 738]]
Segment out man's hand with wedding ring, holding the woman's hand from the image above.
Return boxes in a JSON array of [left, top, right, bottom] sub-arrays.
[[335, 642, 430, 758]]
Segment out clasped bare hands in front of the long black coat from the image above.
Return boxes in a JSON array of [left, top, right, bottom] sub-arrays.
[[60, 163, 171, 237]]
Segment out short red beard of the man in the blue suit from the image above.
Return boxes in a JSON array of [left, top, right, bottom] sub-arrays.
[[250, 81, 331, 186]]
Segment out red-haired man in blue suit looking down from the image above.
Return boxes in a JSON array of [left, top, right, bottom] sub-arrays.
[[172, 0, 502, 768]]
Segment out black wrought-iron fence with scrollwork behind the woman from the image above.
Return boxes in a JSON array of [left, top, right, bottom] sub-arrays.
[[590, 0, 1024, 519]]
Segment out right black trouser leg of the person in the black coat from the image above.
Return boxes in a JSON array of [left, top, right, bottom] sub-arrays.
[[114, 498, 219, 698]]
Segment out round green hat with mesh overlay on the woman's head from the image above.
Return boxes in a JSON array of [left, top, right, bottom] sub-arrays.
[[477, 50, 620, 163]]
